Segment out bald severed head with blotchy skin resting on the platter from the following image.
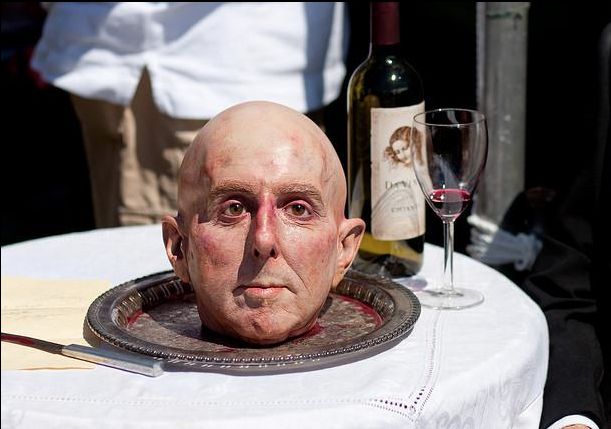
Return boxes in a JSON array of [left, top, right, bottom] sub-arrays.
[[163, 102, 364, 344]]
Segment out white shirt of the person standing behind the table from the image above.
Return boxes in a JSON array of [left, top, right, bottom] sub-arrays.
[[32, 2, 348, 119]]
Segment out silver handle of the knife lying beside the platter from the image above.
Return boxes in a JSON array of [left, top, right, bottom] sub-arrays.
[[62, 344, 163, 377]]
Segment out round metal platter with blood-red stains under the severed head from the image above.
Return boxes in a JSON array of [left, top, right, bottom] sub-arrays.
[[84, 271, 420, 375]]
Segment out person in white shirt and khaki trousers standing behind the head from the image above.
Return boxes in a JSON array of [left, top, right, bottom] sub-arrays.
[[31, 2, 348, 227]]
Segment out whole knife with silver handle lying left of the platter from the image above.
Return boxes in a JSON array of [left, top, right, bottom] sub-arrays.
[[2, 332, 164, 377]]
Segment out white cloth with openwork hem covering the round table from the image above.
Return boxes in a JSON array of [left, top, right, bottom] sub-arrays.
[[1, 225, 548, 429]]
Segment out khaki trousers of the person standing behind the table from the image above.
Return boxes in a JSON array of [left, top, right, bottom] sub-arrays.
[[71, 71, 206, 228]]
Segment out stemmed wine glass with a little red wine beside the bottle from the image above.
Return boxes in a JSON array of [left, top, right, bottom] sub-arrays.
[[411, 109, 488, 310]]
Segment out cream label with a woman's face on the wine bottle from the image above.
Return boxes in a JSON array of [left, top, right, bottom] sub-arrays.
[[371, 102, 426, 240]]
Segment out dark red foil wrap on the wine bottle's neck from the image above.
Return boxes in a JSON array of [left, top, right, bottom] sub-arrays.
[[369, 2, 401, 55]]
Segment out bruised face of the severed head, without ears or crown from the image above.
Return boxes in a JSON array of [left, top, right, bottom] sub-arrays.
[[179, 131, 340, 343]]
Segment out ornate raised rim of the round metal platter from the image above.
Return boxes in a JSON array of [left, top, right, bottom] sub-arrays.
[[83, 270, 421, 374]]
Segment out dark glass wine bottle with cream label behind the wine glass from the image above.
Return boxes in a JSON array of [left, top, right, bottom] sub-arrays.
[[348, 2, 425, 278]]
